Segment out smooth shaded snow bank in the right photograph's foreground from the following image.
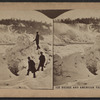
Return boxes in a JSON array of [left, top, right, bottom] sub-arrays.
[[54, 52, 93, 85]]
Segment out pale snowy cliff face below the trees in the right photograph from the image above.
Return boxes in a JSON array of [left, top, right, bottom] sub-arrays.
[[54, 22, 100, 44]]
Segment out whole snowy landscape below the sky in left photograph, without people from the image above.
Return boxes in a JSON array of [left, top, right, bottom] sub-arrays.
[[0, 19, 53, 89]]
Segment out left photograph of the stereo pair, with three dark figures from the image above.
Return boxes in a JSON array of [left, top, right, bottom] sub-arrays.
[[0, 10, 53, 89]]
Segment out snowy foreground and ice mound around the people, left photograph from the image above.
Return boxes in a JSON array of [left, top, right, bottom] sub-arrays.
[[0, 34, 53, 89]]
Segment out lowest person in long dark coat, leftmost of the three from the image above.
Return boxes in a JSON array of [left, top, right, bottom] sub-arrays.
[[27, 57, 36, 78]]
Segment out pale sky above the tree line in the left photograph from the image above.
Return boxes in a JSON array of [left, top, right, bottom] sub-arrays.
[[0, 10, 52, 23]]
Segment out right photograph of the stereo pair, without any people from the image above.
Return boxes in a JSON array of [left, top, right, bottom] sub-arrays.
[[54, 9, 100, 86]]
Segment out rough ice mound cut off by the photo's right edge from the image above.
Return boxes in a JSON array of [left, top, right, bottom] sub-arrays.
[[85, 35, 100, 75]]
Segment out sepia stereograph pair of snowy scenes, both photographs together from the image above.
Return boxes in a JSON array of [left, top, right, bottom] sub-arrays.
[[0, 9, 100, 90]]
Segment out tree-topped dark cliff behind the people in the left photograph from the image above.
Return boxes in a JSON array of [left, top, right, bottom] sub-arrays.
[[0, 19, 52, 44]]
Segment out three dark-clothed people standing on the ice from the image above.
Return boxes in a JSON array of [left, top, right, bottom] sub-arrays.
[[27, 32, 45, 78]]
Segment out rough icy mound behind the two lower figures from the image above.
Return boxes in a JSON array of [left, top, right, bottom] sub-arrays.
[[6, 35, 51, 75]]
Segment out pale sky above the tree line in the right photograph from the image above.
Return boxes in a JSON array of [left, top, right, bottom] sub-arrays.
[[56, 9, 100, 19]]
